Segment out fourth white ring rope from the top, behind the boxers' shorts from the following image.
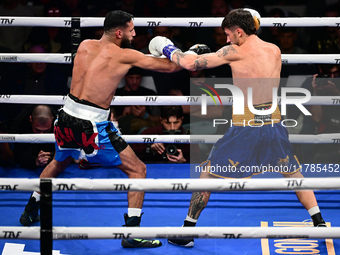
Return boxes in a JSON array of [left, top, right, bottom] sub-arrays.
[[0, 133, 340, 144]]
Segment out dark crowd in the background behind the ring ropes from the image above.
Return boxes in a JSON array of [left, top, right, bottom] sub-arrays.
[[0, 0, 340, 167]]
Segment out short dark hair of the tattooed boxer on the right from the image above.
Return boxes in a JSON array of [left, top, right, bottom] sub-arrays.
[[222, 9, 256, 35]]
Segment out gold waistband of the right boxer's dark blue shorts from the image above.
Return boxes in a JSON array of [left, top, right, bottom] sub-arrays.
[[233, 103, 281, 126]]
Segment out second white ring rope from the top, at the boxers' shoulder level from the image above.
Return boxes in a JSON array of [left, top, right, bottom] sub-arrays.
[[0, 53, 340, 64]]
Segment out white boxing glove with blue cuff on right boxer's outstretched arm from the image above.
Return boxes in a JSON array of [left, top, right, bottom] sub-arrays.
[[149, 36, 180, 60]]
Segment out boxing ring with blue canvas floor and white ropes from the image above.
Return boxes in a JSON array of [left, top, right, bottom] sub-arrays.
[[0, 17, 340, 255]]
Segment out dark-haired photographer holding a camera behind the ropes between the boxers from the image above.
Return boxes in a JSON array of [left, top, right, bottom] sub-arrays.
[[131, 106, 198, 163]]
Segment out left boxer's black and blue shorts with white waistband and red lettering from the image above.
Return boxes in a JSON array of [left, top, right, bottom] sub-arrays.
[[54, 94, 128, 165]]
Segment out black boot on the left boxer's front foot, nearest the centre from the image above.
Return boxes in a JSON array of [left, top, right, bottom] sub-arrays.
[[122, 213, 162, 248]]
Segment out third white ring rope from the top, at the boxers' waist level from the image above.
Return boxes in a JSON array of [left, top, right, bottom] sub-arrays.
[[0, 94, 340, 106]]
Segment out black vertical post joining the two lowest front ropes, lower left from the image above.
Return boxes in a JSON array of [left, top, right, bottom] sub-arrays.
[[40, 179, 53, 255]]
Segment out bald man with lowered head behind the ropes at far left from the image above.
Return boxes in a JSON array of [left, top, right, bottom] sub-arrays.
[[14, 105, 55, 168]]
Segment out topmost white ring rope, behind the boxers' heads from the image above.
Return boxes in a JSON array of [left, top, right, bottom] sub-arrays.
[[0, 16, 340, 27]]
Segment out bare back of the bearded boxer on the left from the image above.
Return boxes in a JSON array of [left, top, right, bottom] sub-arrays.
[[70, 40, 130, 108]]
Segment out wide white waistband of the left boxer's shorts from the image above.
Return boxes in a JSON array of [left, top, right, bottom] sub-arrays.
[[63, 95, 110, 122]]
